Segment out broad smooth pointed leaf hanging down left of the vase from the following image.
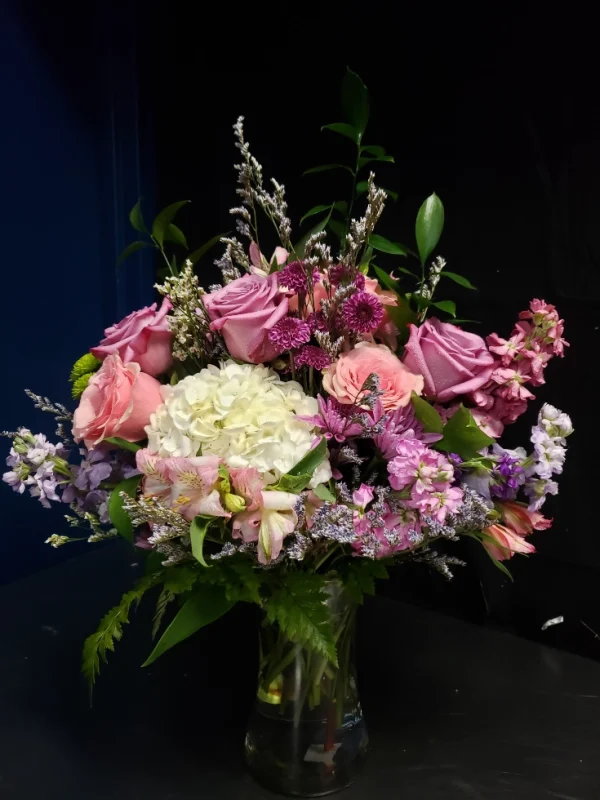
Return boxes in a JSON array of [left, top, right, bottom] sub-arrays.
[[142, 583, 233, 667]]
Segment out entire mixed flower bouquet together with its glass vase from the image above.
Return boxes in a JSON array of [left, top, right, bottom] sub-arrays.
[[3, 71, 572, 796]]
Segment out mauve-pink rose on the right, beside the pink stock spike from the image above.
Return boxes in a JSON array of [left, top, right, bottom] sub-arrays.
[[402, 318, 494, 403]]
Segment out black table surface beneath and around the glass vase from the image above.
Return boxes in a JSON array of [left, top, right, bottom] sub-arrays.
[[0, 544, 600, 800]]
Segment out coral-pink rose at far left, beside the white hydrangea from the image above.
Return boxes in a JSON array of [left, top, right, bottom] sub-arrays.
[[73, 354, 162, 449]]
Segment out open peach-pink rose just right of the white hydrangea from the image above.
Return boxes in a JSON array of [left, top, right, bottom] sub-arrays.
[[323, 342, 423, 411]]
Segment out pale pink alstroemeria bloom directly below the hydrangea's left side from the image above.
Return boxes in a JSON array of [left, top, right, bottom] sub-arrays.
[[136, 450, 231, 522]]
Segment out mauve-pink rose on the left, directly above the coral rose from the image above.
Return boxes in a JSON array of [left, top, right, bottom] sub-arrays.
[[92, 297, 173, 375]]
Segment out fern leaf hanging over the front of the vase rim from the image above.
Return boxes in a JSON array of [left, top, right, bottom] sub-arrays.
[[265, 572, 337, 664]]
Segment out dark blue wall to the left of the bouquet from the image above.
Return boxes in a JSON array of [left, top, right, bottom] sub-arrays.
[[0, 0, 152, 581]]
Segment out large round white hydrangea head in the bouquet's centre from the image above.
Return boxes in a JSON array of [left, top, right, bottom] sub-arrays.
[[146, 361, 331, 486]]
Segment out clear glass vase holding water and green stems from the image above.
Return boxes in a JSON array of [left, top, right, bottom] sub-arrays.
[[245, 582, 368, 797]]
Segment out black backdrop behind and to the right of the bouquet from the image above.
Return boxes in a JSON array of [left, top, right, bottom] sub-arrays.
[[141, 0, 600, 657]]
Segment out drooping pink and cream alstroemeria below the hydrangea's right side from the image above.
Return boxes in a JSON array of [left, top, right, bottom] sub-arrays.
[[230, 467, 298, 564]]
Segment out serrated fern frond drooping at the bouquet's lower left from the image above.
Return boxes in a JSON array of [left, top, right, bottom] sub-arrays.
[[81, 574, 161, 695]]
